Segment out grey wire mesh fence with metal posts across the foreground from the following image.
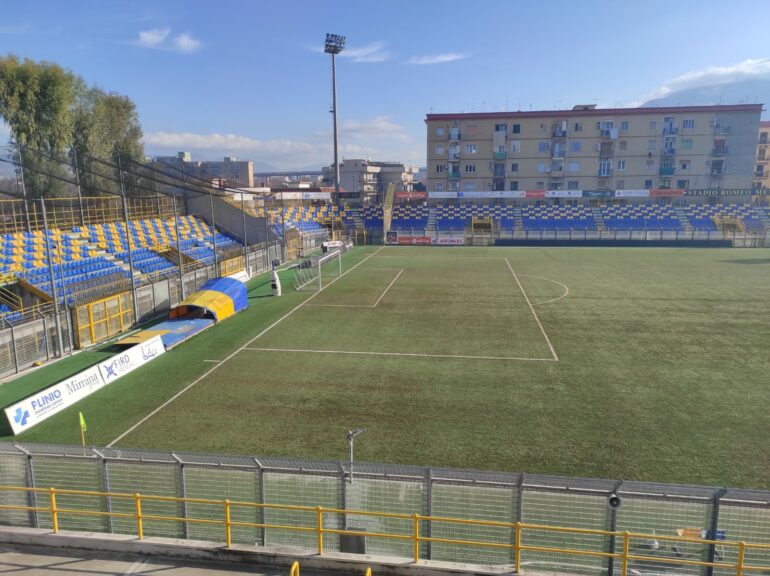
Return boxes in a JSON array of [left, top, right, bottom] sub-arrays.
[[0, 443, 770, 576]]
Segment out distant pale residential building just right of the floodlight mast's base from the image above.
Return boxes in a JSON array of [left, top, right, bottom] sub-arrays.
[[323, 158, 417, 196]]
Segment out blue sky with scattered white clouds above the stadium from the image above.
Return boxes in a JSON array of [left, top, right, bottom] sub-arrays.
[[0, 0, 770, 169]]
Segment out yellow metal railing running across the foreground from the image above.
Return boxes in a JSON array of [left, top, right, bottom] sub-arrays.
[[0, 486, 770, 576]]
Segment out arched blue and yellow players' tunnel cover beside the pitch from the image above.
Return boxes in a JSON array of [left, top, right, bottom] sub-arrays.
[[168, 278, 248, 322]]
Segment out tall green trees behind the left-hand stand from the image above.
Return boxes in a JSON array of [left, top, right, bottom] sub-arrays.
[[0, 55, 144, 197]]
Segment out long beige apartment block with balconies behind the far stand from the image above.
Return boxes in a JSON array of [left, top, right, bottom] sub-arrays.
[[426, 104, 762, 192]]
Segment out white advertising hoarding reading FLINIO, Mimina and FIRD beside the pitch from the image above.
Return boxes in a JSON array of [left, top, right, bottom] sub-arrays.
[[5, 336, 166, 434]]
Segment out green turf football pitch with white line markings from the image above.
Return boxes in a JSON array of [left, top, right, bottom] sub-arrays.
[[6, 247, 770, 488]]
